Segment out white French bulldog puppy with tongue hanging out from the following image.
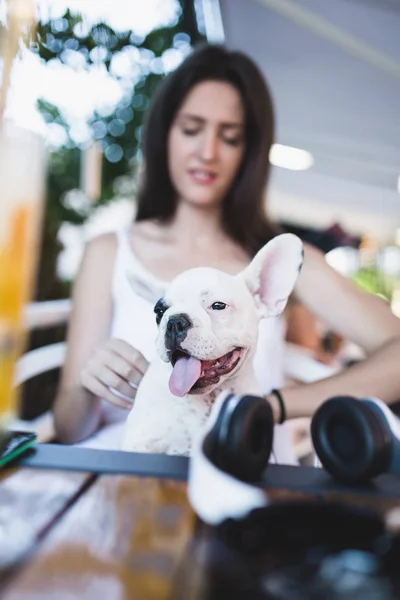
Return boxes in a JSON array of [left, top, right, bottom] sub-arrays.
[[122, 234, 303, 455]]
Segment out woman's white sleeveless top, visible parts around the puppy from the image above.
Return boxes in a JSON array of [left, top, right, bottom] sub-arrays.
[[79, 228, 297, 464]]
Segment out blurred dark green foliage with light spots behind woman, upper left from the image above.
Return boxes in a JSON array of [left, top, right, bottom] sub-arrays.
[[22, 0, 202, 299]]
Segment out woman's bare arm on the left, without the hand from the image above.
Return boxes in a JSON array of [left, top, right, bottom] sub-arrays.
[[53, 234, 116, 443]]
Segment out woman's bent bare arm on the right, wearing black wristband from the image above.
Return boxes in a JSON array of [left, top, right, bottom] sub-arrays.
[[271, 246, 400, 418]]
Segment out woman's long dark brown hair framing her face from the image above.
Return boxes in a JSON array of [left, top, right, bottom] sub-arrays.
[[136, 44, 277, 255]]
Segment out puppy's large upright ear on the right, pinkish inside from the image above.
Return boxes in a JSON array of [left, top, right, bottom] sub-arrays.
[[240, 233, 303, 317]]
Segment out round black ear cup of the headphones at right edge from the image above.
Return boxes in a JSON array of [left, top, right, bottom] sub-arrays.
[[311, 396, 391, 483]]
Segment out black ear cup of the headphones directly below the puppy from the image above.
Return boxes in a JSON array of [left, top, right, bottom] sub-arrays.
[[207, 396, 274, 481]]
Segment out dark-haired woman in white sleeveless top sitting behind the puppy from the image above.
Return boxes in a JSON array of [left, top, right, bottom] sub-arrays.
[[54, 45, 400, 462]]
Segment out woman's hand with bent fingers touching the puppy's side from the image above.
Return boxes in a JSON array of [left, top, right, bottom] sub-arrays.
[[80, 339, 149, 410]]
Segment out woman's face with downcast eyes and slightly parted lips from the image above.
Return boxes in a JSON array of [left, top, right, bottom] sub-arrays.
[[168, 81, 245, 207]]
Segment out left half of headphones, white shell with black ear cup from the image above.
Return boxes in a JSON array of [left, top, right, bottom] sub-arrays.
[[188, 392, 274, 524]]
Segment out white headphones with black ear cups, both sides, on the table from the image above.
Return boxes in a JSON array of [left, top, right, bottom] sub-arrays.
[[188, 392, 400, 525]]
